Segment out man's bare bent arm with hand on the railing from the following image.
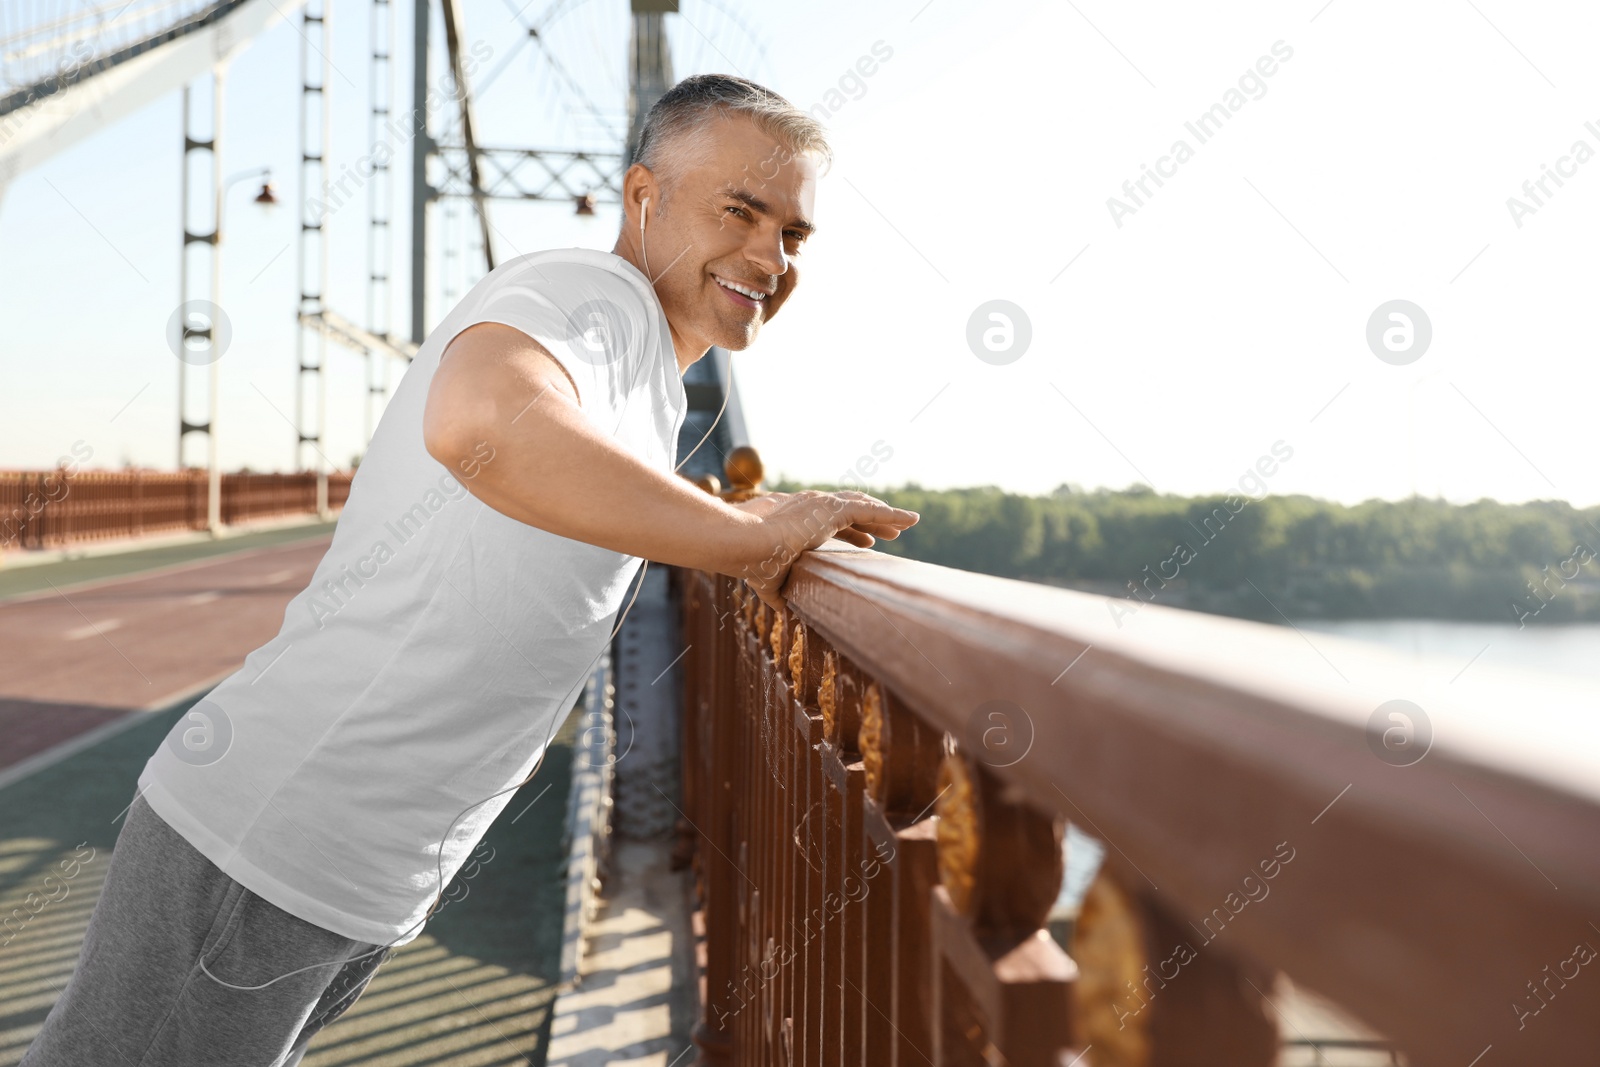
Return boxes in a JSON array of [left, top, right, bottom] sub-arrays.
[[422, 323, 917, 606]]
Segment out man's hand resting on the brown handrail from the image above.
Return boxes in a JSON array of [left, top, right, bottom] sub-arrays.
[[725, 490, 920, 608]]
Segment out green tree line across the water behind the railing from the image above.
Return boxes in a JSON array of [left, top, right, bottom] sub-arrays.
[[774, 483, 1600, 625]]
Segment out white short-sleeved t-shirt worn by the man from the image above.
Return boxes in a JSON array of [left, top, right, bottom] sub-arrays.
[[139, 248, 688, 944]]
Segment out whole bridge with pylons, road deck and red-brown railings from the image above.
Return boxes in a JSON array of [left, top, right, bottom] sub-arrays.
[[0, 0, 1600, 1067]]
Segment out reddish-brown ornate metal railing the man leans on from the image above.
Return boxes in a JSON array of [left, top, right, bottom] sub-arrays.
[[677, 550, 1600, 1067]]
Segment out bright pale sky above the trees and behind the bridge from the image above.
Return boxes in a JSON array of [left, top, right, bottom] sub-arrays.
[[0, 0, 1600, 506]]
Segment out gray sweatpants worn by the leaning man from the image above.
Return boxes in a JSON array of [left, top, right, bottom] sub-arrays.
[[21, 797, 390, 1067]]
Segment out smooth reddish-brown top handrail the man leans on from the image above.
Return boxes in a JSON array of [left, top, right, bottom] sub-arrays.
[[786, 542, 1600, 1064]]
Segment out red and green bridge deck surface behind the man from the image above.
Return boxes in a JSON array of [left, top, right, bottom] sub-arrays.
[[0, 528, 579, 1067]]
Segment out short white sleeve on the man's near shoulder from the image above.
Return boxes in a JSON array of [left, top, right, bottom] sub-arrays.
[[444, 262, 651, 418]]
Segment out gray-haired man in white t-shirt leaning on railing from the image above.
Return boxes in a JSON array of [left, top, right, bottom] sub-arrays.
[[22, 75, 917, 1067]]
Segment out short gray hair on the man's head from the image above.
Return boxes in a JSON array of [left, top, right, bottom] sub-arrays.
[[634, 74, 834, 207]]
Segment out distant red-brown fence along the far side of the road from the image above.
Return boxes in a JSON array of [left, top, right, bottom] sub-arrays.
[[0, 470, 350, 549]]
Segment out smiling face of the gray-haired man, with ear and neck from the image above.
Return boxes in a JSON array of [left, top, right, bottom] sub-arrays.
[[616, 114, 818, 368]]
